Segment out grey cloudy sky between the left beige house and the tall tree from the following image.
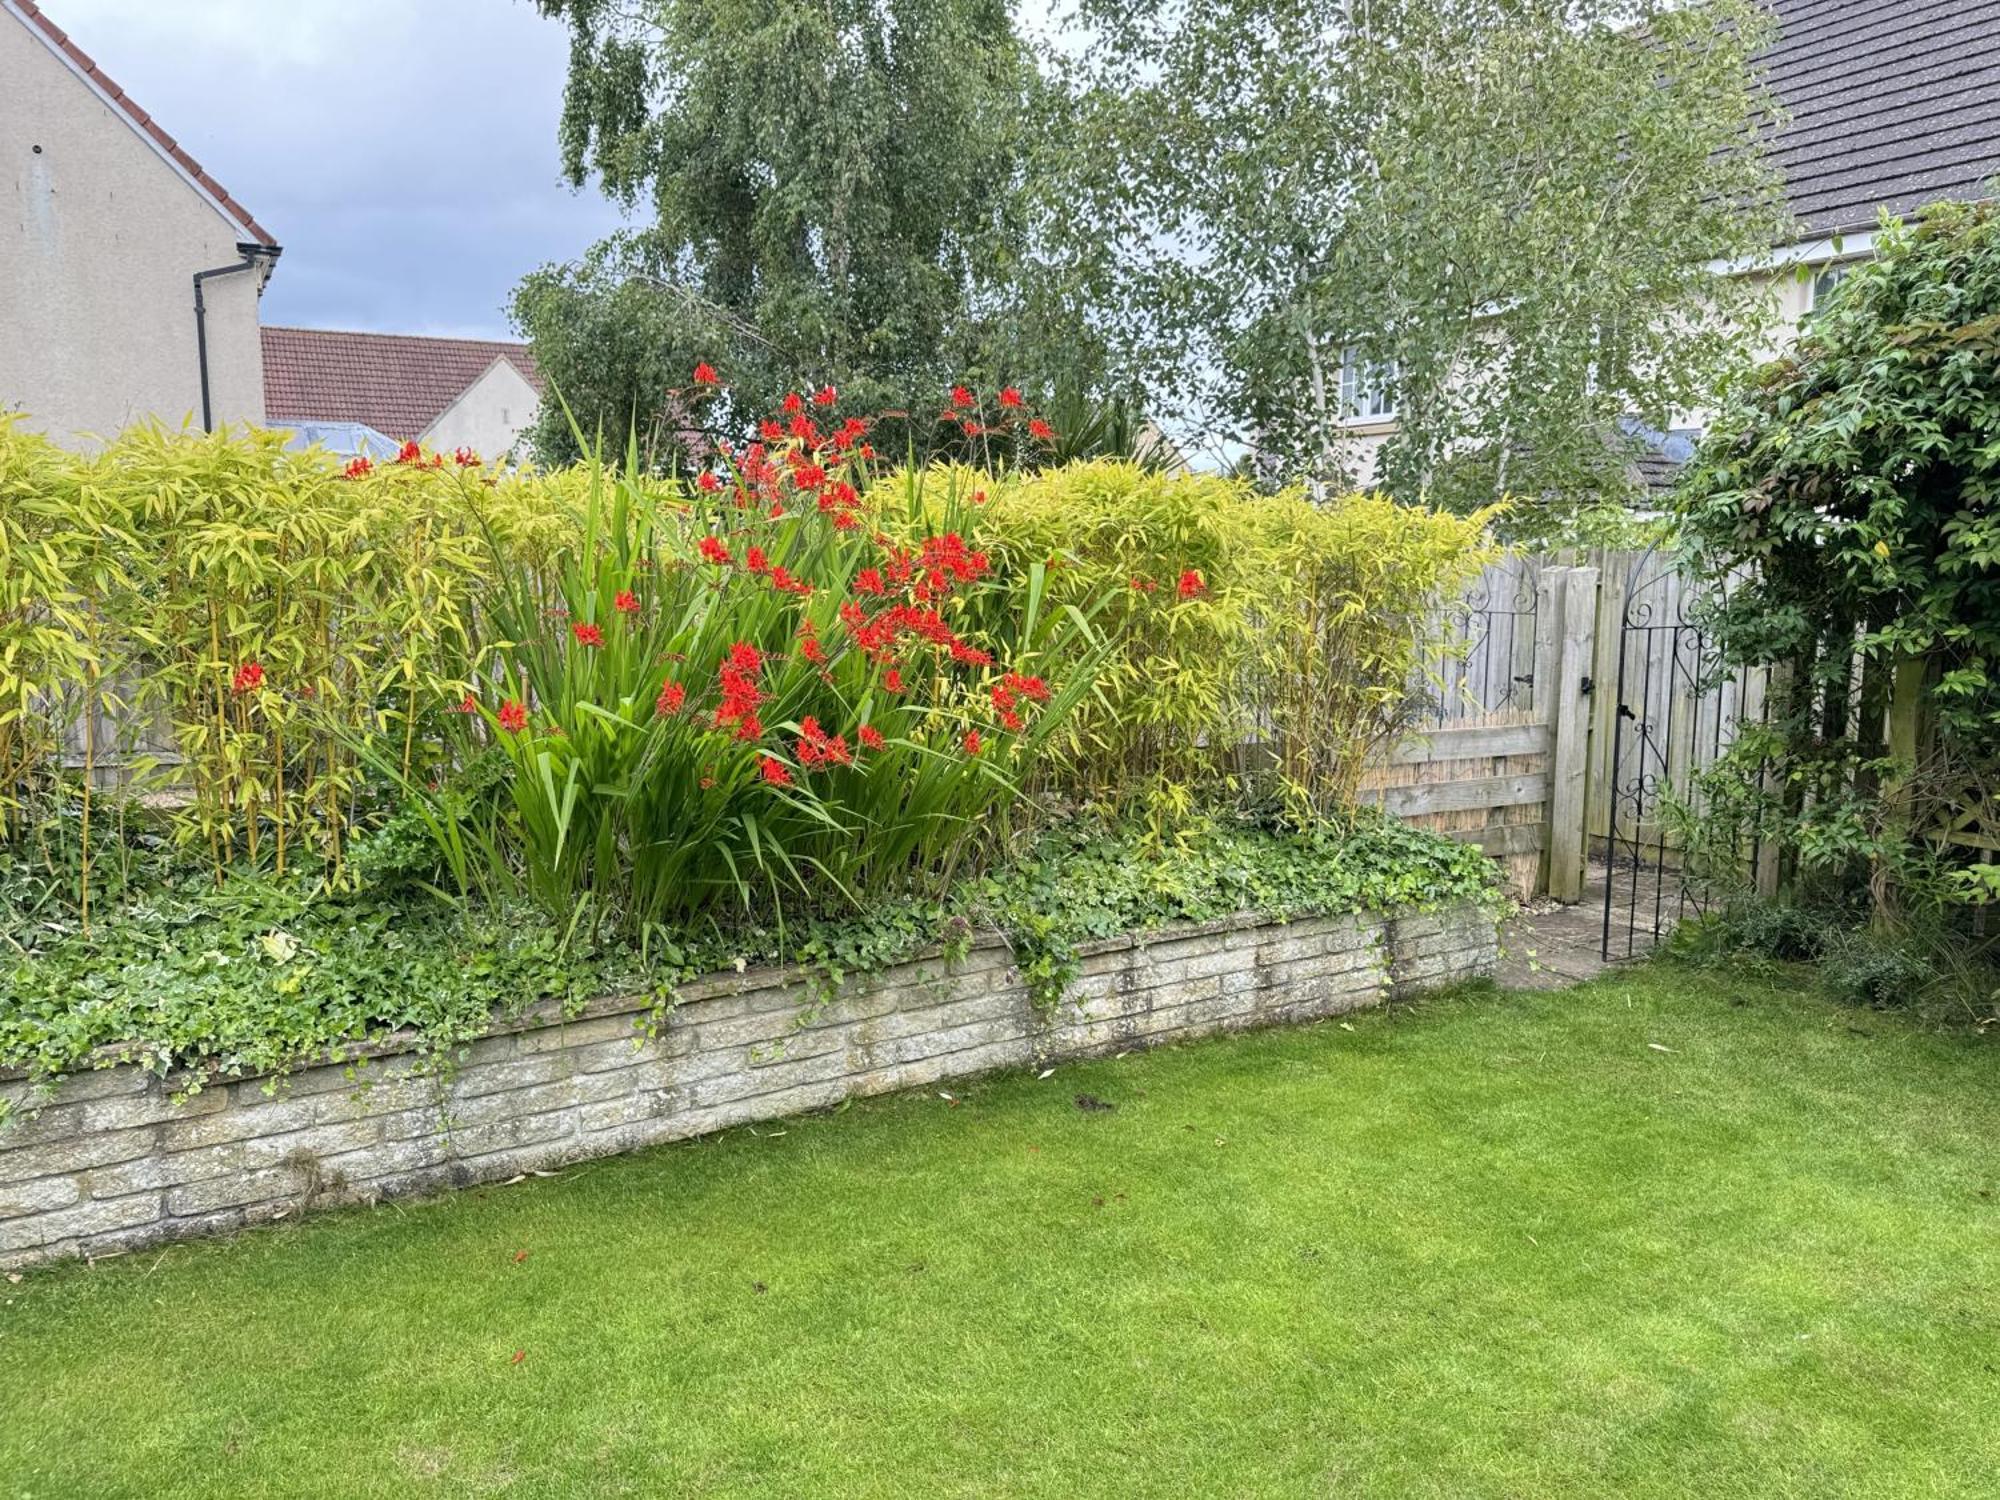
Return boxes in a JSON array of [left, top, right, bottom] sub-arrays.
[[42, 0, 618, 338]]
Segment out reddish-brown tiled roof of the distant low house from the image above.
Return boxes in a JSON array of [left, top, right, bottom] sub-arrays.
[[262, 328, 542, 442]]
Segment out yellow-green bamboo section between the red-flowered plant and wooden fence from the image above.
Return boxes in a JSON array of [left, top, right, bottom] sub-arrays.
[[884, 462, 1490, 816]]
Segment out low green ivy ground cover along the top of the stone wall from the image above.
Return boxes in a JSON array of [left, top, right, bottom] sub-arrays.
[[0, 820, 1492, 1088]]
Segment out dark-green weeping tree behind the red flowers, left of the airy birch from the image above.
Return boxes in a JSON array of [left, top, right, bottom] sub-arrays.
[[514, 0, 1102, 462]]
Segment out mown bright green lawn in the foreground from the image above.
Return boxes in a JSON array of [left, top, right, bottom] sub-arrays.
[[0, 968, 2000, 1500]]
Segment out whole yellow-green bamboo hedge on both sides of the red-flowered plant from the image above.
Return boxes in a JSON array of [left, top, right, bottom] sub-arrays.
[[0, 420, 1486, 870]]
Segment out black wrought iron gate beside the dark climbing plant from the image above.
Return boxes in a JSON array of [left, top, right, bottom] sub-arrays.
[[1592, 550, 1762, 960]]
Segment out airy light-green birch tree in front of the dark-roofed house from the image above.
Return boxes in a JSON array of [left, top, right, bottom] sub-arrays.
[[1044, 0, 1782, 508]]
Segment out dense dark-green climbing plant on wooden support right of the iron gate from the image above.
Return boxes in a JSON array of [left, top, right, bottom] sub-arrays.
[[1678, 204, 2000, 922]]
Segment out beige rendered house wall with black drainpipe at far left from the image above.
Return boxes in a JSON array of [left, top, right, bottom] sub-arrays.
[[0, 0, 278, 444]]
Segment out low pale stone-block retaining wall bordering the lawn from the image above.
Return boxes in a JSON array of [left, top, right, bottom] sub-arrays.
[[0, 908, 1496, 1268]]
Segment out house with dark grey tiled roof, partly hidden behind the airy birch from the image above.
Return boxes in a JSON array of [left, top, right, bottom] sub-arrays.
[[1340, 0, 2000, 494]]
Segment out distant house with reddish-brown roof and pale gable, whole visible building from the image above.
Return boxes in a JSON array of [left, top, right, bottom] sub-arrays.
[[264, 328, 542, 460]]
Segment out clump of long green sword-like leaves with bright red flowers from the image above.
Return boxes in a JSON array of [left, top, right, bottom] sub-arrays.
[[408, 446, 1102, 928]]
